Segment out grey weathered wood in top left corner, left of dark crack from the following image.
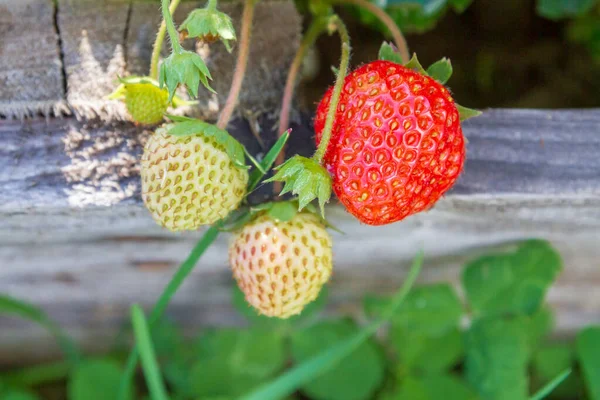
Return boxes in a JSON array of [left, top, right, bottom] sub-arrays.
[[0, 0, 65, 117]]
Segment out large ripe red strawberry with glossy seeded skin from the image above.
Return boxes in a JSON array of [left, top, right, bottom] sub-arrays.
[[315, 61, 465, 225]]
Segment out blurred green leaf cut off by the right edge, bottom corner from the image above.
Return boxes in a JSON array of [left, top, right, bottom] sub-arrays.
[[576, 325, 600, 400]]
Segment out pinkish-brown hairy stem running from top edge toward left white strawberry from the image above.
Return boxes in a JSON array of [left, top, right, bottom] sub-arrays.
[[216, 0, 257, 129]]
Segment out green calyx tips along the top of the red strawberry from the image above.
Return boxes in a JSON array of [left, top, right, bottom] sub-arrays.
[[379, 42, 481, 122]]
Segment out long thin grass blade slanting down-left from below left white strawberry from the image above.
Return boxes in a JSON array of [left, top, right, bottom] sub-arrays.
[[117, 227, 220, 400]]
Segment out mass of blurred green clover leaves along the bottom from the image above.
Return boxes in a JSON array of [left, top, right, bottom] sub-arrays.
[[0, 240, 600, 400]]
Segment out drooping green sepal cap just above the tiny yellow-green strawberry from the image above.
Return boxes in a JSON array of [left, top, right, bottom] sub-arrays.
[[159, 50, 216, 102]]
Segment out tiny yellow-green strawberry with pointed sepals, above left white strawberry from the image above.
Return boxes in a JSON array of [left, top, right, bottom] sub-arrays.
[[109, 77, 195, 125]]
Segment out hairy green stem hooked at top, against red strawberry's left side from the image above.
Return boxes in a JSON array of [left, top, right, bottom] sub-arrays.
[[313, 15, 350, 164]]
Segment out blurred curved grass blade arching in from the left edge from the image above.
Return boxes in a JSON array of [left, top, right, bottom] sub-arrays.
[[0, 295, 81, 364]]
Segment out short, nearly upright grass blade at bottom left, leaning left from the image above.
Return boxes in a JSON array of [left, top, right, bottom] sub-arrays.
[[131, 304, 169, 400]]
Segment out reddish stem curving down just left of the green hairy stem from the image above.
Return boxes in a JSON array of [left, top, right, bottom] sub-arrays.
[[275, 18, 328, 170]]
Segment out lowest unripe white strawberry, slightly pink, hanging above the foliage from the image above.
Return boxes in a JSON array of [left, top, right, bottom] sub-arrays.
[[229, 213, 332, 318]]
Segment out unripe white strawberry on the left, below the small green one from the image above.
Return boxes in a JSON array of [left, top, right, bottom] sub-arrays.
[[140, 128, 248, 231]]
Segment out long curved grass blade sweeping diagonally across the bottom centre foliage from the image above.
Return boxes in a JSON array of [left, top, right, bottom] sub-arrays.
[[240, 253, 423, 400]]
